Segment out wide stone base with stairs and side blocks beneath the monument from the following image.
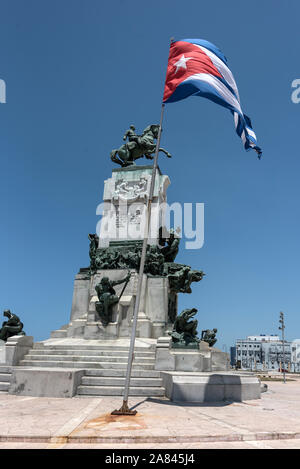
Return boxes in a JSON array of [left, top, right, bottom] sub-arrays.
[[2, 337, 261, 403]]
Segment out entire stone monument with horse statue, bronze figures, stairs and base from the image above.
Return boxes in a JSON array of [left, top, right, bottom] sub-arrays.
[[5, 124, 260, 402]]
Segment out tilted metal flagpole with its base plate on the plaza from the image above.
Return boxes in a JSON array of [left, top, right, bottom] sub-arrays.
[[112, 104, 165, 415]]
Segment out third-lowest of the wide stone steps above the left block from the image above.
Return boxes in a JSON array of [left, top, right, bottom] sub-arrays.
[[27, 349, 155, 358]]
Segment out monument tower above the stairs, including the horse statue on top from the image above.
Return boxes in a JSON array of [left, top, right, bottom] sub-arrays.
[[53, 124, 227, 371]]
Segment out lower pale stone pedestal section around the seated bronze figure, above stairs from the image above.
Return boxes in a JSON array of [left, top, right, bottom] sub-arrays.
[[59, 269, 170, 340]]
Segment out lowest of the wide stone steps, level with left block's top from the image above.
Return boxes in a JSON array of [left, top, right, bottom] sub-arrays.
[[19, 360, 154, 370]]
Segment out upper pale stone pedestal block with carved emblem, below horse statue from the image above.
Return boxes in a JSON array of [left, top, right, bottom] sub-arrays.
[[99, 166, 170, 247]]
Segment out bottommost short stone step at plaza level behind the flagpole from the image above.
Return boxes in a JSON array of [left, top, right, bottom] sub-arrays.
[[77, 385, 165, 397]]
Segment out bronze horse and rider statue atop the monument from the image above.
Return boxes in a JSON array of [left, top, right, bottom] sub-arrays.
[[110, 124, 171, 167]]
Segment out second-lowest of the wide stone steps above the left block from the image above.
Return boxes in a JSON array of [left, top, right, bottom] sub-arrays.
[[24, 354, 155, 366]]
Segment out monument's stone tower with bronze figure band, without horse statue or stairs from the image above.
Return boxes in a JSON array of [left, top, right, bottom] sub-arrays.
[[61, 161, 204, 340]]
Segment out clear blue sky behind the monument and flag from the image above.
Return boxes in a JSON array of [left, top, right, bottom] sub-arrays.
[[0, 0, 300, 348]]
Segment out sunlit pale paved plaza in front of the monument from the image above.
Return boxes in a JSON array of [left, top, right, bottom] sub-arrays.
[[0, 378, 300, 449]]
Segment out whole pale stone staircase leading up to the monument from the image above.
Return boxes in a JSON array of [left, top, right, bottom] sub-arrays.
[[19, 339, 165, 397]]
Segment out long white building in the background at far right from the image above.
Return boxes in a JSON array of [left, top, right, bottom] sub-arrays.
[[235, 334, 300, 372]]
